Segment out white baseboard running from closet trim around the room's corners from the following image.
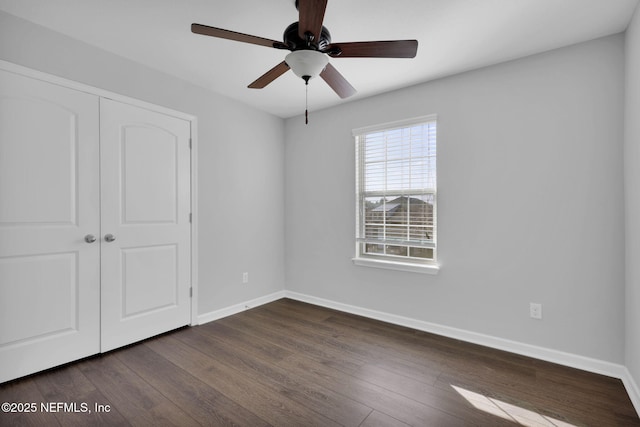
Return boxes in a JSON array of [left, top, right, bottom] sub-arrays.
[[192, 291, 640, 414]]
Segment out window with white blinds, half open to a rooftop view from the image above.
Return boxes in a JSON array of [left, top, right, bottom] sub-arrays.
[[353, 116, 436, 271]]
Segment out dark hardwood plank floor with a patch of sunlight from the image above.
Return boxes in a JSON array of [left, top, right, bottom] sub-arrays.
[[0, 299, 640, 427]]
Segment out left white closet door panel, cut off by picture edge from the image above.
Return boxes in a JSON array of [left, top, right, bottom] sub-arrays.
[[0, 70, 100, 382]]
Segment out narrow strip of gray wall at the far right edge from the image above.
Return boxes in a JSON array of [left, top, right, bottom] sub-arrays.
[[624, 1, 640, 393]]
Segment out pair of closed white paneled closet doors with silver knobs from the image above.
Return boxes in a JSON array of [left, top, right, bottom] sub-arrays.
[[0, 70, 191, 383]]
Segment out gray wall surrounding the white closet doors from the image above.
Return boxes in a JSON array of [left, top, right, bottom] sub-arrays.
[[0, 12, 284, 314]]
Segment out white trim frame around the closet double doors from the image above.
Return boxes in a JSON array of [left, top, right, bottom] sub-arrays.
[[0, 59, 198, 326]]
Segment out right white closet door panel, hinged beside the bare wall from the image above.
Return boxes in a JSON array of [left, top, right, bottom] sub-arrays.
[[100, 99, 191, 352]]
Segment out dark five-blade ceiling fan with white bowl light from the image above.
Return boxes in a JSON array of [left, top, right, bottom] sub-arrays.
[[191, 0, 418, 117]]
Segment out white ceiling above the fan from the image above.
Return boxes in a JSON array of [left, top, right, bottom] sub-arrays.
[[0, 0, 638, 118]]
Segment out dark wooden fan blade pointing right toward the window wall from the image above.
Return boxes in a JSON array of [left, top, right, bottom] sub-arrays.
[[325, 40, 418, 58]]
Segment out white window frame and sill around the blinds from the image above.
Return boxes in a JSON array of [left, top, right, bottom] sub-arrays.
[[352, 114, 440, 274]]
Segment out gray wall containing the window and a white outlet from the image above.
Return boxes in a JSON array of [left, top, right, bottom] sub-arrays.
[[285, 35, 625, 363]]
